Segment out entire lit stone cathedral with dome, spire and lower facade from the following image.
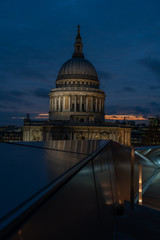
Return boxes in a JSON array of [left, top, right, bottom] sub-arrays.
[[23, 26, 131, 146]]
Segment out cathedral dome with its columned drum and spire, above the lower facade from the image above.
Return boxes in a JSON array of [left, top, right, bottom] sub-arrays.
[[49, 26, 105, 123]]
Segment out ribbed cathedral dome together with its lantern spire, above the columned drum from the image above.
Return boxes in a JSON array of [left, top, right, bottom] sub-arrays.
[[57, 26, 98, 81]]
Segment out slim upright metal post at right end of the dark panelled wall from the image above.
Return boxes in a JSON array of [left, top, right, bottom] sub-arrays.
[[130, 148, 135, 209]]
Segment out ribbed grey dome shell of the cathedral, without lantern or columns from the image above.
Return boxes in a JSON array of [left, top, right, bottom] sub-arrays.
[[57, 57, 98, 81]]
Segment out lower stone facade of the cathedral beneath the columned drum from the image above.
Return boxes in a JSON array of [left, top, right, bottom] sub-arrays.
[[23, 120, 131, 146]]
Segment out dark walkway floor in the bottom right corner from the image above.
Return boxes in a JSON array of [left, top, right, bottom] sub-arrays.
[[115, 202, 160, 240]]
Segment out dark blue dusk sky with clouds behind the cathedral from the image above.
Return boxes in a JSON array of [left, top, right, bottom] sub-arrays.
[[0, 0, 160, 125]]
